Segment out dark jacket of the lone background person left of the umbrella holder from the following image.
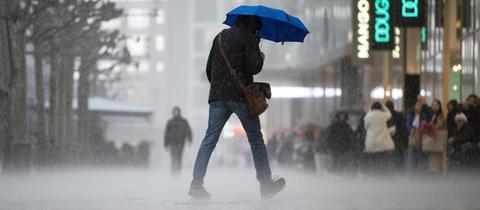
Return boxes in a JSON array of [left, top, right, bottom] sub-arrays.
[[163, 117, 192, 147]]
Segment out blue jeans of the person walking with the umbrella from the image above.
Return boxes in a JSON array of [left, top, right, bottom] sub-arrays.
[[193, 101, 272, 184]]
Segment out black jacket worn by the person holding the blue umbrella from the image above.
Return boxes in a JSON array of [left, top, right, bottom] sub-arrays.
[[206, 26, 263, 103]]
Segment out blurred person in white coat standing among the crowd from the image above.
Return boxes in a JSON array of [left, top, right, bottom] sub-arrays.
[[365, 102, 395, 172]]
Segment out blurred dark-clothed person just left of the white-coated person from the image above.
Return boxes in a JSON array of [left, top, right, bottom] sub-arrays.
[[327, 112, 353, 173]]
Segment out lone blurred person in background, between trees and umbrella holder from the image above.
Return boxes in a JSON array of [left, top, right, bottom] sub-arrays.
[[163, 107, 192, 175]]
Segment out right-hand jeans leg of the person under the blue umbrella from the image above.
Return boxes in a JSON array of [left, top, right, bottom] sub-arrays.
[[229, 102, 272, 184]]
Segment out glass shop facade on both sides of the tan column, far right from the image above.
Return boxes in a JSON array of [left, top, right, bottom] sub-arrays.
[[421, 0, 480, 100]]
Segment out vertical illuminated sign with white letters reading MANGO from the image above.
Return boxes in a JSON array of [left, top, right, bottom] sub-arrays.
[[356, 0, 370, 59]]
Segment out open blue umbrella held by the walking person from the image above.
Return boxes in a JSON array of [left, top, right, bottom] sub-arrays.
[[223, 6, 310, 43]]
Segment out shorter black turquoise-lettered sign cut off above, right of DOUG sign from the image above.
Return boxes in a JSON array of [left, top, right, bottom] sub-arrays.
[[394, 0, 427, 27]]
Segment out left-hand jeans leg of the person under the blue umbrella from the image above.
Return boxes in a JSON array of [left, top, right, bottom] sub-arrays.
[[192, 101, 232, 185]]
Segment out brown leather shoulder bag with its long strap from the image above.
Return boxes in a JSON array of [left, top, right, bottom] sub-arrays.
[[218, 35, 272, 116]]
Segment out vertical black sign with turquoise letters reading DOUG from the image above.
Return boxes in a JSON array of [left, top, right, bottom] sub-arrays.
[[370, 0, 394, 50]]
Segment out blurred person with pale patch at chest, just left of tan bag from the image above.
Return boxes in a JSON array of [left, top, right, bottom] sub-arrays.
[[405, 101, 428, 174]]
